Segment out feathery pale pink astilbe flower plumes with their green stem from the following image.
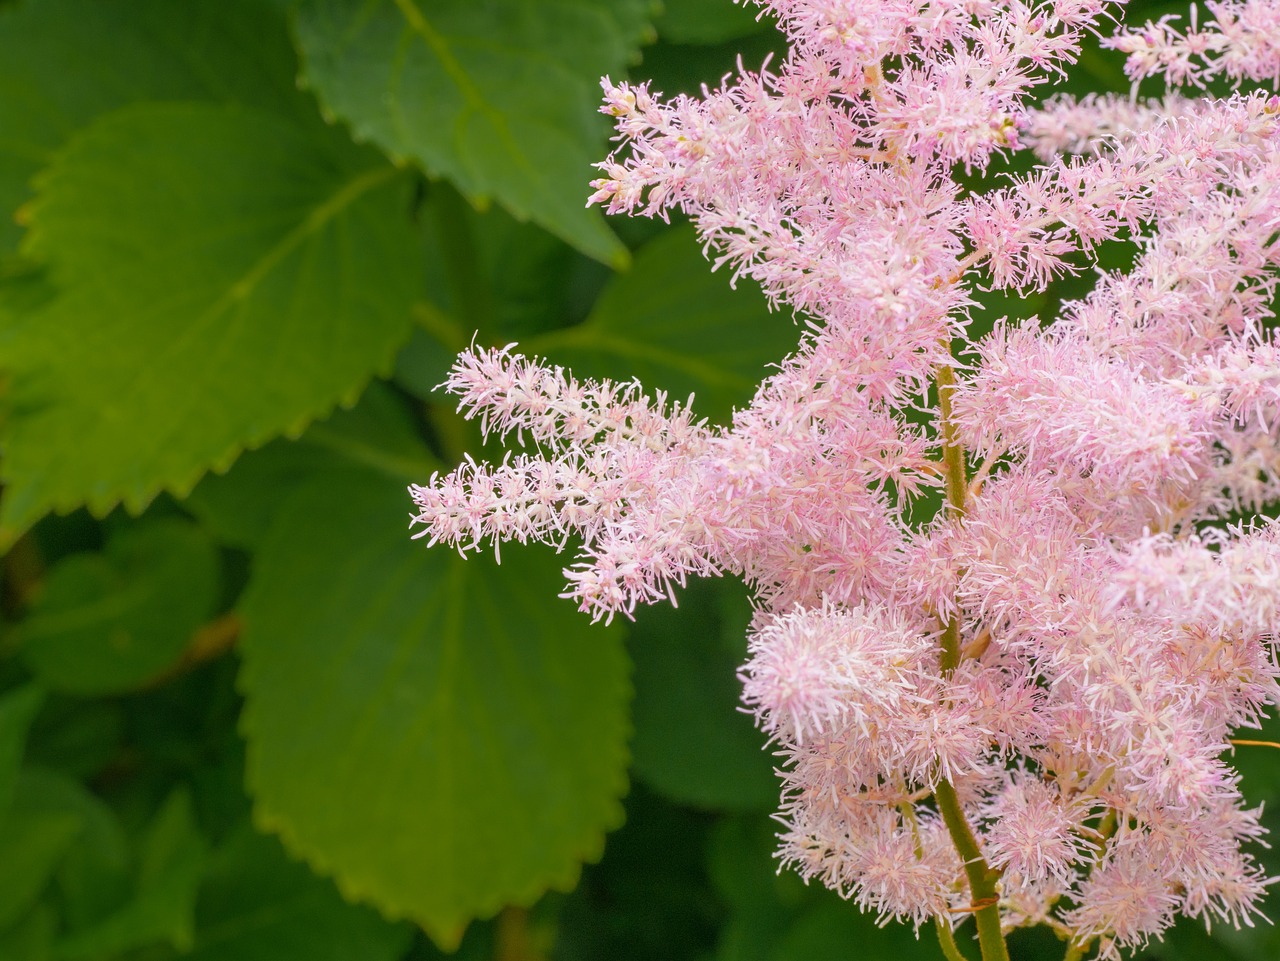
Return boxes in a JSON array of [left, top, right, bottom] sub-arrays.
[[412, 0, 1280, 961]]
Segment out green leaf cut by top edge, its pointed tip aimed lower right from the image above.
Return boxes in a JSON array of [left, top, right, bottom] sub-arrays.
[[296, 0, 649, 264]]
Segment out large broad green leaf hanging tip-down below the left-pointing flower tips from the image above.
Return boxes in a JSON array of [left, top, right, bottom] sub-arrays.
[[241, 473, 630, 947]]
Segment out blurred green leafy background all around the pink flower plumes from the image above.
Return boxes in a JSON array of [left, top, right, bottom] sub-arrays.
[[0, 0, 1280, 961]]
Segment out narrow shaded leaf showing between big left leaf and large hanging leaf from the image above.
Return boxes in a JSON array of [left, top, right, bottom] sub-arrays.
[[186, 381, 436, 550]]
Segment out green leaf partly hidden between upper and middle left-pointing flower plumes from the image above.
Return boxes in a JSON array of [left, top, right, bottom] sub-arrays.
[[521, 228, 800, 422]]
